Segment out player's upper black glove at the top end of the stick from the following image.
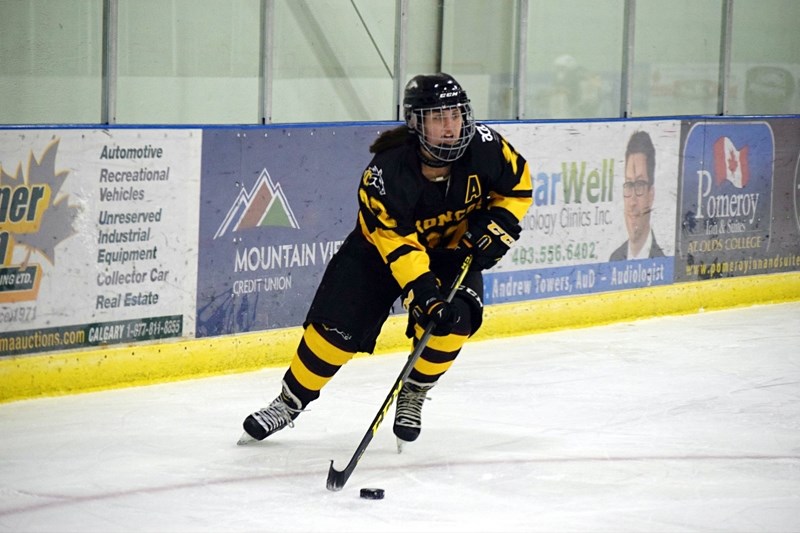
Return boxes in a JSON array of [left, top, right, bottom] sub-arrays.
[[459, 212, 522, 270]]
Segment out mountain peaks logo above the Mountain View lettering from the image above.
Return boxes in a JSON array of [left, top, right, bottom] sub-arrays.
[[214, 168, 300, 239]]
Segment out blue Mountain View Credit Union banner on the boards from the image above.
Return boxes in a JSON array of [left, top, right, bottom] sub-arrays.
[[196, 125, 380, 337]]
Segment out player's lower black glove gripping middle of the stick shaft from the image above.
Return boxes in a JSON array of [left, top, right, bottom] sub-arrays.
[[403, 272, 461, 336]]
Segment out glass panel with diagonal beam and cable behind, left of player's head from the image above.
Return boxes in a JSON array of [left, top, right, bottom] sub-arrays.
[[272, 0, 395, 122]]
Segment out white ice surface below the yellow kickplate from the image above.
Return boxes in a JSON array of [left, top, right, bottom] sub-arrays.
[[0, 303, 800, 533]]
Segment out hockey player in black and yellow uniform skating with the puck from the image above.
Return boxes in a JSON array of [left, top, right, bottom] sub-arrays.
[[239, 73, 532, 445]]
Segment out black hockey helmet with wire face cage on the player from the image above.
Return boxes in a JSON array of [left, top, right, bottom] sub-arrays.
[[403, 72, 475, 164]]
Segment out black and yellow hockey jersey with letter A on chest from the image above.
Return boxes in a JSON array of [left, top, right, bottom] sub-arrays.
[[358, 124, 532, 287]]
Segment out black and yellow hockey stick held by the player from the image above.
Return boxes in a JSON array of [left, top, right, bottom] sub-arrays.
[[326, 255, 472, 491]]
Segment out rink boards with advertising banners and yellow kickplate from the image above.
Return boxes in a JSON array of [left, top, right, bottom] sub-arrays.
[[0, 117, 800, 401]]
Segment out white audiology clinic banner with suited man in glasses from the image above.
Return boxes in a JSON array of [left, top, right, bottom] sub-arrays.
[[484, 121, 681, 303]]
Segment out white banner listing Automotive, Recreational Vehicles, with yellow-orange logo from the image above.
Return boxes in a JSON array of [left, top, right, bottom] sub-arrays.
[[0, 129, 202, 356]]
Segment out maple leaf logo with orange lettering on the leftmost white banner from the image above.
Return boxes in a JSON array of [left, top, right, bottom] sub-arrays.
[[0, 141, 80, 303]]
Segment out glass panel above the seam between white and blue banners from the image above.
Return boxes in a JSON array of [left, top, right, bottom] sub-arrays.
[[116, 0, 260, 124]]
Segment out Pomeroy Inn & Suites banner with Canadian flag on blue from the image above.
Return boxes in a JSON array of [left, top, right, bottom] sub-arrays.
[[676, 118, 800, 281]]
